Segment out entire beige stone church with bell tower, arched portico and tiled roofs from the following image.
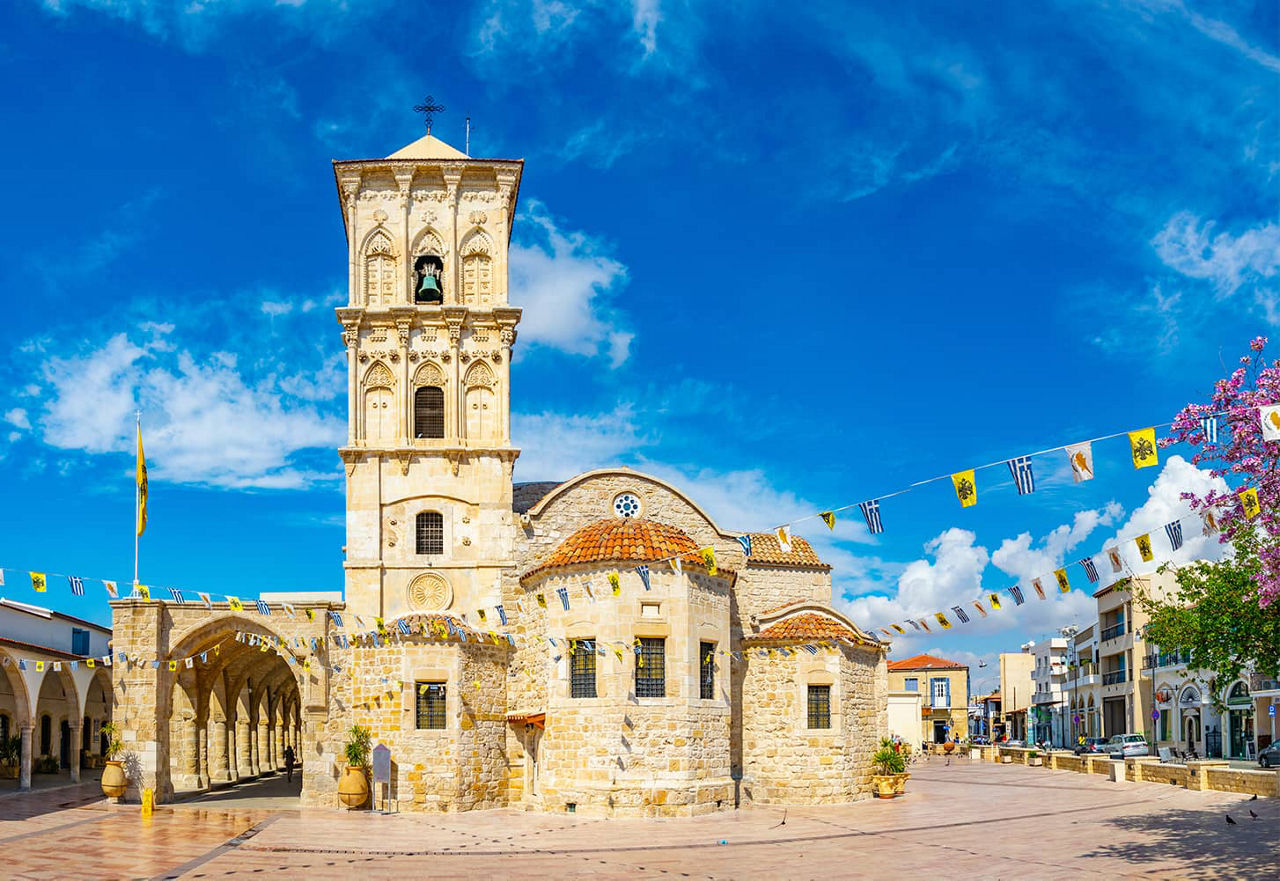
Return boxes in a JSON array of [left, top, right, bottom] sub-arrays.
[[113, 134, 887, 816]]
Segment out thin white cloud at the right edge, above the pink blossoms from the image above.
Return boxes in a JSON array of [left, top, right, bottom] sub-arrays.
[[1151, 211, 1280, 297]]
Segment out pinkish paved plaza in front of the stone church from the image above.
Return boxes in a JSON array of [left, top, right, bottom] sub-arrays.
[[0, 758, 1280, 880]]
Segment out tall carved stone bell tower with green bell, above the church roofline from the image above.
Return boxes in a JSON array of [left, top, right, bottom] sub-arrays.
[[333, 134, 524, 618]]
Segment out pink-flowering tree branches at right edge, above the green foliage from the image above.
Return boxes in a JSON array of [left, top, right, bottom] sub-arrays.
[[1160, 337, 1280, 608]]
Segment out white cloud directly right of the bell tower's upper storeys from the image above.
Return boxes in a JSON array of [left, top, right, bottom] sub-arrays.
[[509, 201, 634, 366]]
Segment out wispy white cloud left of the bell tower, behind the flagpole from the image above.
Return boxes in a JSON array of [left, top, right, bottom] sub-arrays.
[[37, 333, 346, 488]]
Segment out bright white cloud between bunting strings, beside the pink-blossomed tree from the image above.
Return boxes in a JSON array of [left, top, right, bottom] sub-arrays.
[[1098, 456, 1230, 584]]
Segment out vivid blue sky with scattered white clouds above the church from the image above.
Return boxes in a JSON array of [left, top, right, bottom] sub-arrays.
[[0, 0, 1280, 676]]
